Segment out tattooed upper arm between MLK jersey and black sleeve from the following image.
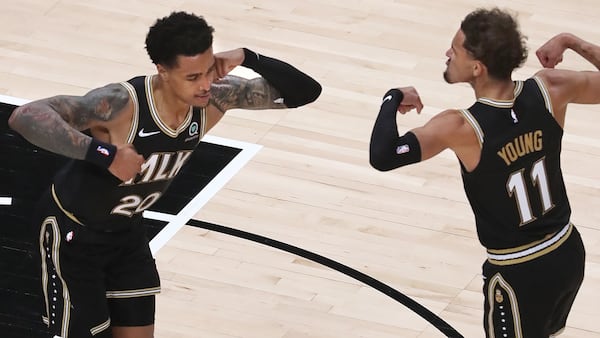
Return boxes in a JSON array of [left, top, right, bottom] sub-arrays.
[[211, 75, 287, 112]]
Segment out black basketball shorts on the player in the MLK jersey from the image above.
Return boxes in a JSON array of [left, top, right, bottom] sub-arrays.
[[39, 189, 160, 338]]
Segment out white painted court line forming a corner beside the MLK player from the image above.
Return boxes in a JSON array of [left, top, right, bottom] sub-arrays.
[[144, 135, 262, 255]]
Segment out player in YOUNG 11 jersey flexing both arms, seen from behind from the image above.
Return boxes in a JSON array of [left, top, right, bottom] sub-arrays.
[[370, 8, 600, 338]]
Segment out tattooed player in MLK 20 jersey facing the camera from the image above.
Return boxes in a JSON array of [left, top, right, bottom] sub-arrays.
[[9, 12, 321, 338]]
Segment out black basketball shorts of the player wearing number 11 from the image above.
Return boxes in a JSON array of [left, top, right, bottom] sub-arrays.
[[483, 224, 585, 338]]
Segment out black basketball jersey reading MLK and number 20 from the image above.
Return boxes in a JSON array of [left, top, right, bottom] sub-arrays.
[[54, 76, 206, 231]]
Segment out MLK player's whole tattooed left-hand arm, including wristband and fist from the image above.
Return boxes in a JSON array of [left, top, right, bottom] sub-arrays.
[[8, 84, 144, 181]]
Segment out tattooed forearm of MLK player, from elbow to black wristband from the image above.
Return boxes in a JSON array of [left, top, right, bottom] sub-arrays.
[[8, 103, 91, 159]]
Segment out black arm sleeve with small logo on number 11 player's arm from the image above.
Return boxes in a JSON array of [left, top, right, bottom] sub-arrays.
[[369, 89, 421, 171]]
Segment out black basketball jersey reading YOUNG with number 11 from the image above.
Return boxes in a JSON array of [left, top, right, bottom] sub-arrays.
[[461, 78, 571, 249]]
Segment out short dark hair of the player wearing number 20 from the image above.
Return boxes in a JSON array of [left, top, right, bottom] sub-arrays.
[[146, 12, 214, 68]]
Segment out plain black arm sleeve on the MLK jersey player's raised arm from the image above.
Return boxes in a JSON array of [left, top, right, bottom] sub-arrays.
[[242, 48, 322, 108]]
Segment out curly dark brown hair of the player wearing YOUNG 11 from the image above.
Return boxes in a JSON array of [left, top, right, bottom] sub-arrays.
[[460, 8, 528, 80]]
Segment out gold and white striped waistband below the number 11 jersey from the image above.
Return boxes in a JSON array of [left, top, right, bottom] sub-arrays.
[[487, 223, 573, 265]]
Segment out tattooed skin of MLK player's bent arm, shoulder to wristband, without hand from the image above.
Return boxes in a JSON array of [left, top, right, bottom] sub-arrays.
[[9, 84, 129, 159]]
